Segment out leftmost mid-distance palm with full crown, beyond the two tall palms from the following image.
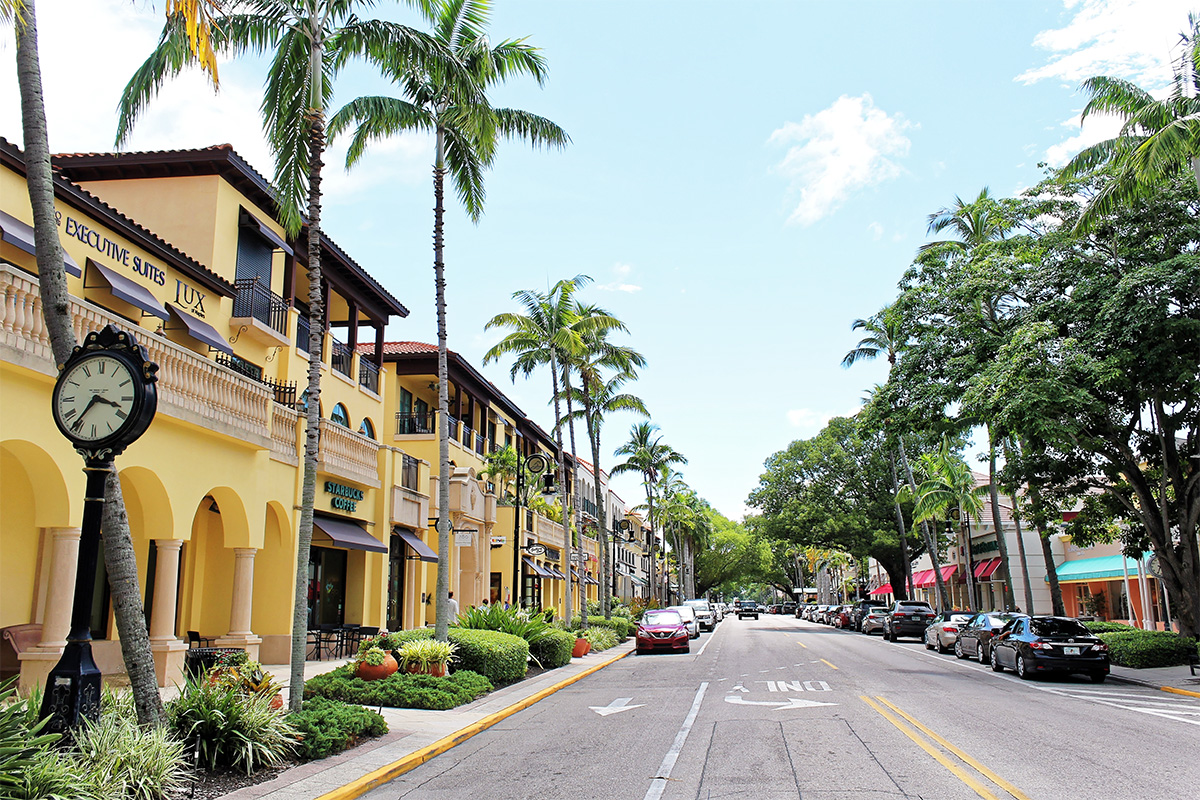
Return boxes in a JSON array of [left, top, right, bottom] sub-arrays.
[[484, 275, 596, 620]]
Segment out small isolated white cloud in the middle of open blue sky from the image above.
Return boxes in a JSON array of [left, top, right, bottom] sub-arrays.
[[769, 94, 913, 225]]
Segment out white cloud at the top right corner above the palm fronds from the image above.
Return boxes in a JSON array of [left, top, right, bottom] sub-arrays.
[[1016, 0, 1194, 89]]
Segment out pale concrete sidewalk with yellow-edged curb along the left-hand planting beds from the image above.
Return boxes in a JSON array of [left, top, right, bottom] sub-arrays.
[[223, 639, 634, 800]]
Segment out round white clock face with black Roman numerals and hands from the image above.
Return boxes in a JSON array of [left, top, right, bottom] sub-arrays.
[[54, 354, 139, 443]]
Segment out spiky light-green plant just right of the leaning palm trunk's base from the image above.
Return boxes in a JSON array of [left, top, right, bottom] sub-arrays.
[[167, 679, 295, 775]]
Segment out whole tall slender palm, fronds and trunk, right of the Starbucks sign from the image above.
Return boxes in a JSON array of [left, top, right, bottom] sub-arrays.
[[330, 0, 570, 640]]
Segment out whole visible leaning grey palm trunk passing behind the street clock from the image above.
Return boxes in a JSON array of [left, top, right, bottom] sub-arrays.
[[16, 0, 163, 727]]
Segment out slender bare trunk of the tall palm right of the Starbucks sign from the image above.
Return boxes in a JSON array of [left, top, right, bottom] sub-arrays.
[[433, 125, 451, 642]]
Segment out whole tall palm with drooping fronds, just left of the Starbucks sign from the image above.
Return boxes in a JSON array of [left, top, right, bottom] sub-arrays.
[[116, 0, 449, 710]]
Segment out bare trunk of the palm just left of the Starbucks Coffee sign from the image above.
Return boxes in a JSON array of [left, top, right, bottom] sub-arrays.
[[288, 103, 325, 711]]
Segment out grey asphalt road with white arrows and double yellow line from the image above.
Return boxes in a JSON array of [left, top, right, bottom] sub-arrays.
[[366, 615, 1200, 800]]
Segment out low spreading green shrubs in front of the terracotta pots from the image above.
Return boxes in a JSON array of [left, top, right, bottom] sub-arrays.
[[304, 664, 496, 711]]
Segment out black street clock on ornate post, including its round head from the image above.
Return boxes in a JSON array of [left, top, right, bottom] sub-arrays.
[[42, 325, 158, 733]]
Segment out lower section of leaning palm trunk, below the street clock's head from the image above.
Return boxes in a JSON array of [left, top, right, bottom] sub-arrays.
[[101, 469, 166, 727]]
